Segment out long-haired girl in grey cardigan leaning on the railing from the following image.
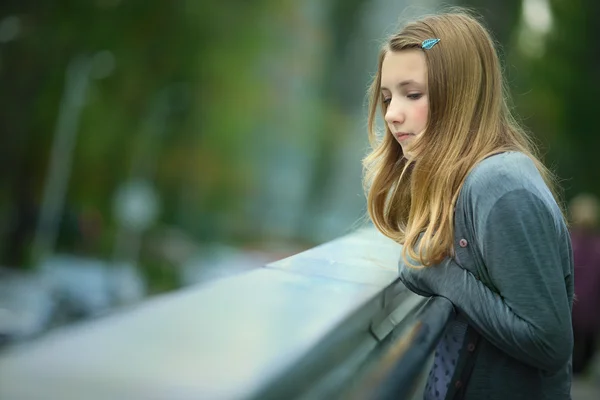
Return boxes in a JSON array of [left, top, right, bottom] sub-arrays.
[[364, 11, 573, 400]]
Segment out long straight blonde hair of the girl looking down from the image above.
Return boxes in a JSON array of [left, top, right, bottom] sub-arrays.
[[363, 9, 560, 266]]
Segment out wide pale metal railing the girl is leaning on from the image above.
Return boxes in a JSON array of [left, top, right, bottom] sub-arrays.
[[0, 229, 452, 400]]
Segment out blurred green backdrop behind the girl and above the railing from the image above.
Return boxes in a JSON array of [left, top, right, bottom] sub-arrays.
[[0, 0, 600, 390]]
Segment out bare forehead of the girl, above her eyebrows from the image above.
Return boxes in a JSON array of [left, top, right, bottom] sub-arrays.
[[381, 49, 427, 89]]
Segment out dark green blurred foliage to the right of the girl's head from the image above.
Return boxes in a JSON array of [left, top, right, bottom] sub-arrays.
[[514, 0, 600, 197]]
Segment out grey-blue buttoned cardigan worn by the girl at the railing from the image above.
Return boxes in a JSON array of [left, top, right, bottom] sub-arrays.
[[399, 152, 573, 400]]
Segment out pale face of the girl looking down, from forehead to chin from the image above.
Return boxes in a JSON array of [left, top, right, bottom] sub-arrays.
[[381, 49, 429, 158]]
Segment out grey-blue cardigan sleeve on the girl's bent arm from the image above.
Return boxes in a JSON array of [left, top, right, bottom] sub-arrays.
[[401, 189, 573, 372]]
